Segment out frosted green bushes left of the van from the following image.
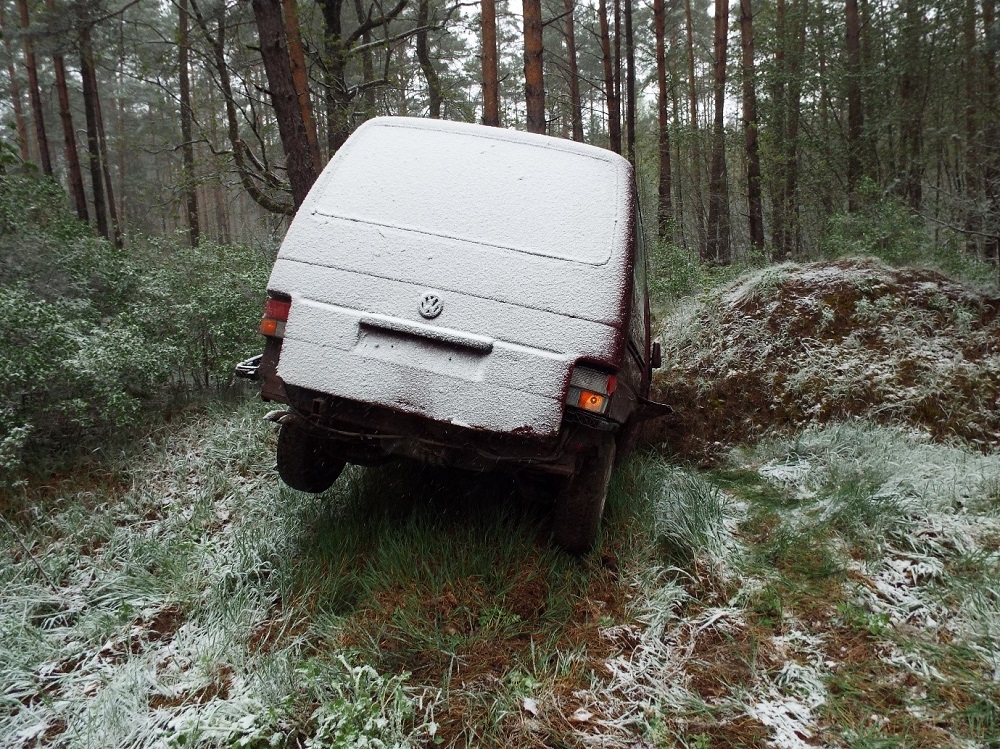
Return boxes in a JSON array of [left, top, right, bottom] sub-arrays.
[[0, 167, 270, 485]]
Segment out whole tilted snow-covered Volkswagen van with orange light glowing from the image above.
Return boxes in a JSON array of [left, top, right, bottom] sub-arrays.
[[239, 117, 659, 552]]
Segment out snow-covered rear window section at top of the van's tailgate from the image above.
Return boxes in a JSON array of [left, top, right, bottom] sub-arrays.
[[303, 117, 631, 265]]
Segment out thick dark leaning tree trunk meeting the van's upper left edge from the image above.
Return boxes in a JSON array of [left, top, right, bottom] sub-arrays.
[[252, 0, 317, 210]]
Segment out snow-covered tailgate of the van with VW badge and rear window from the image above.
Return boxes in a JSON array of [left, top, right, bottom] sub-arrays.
[[269, 118, 633, 435]]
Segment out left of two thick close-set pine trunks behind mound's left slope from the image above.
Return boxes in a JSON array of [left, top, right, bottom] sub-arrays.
[[707, 0, 732, 265]]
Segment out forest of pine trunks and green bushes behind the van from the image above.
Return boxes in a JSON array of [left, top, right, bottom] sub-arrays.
[[0, 0, 1000, 482]]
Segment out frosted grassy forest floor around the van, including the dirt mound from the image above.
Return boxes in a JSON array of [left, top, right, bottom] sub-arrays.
[[0, 261, 1000, 748]]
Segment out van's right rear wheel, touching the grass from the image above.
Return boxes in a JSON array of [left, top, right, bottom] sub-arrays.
[[553, 434, 615, 554]]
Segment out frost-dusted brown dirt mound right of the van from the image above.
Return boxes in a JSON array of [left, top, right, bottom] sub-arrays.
[[647, 259, 1000, 463]]
